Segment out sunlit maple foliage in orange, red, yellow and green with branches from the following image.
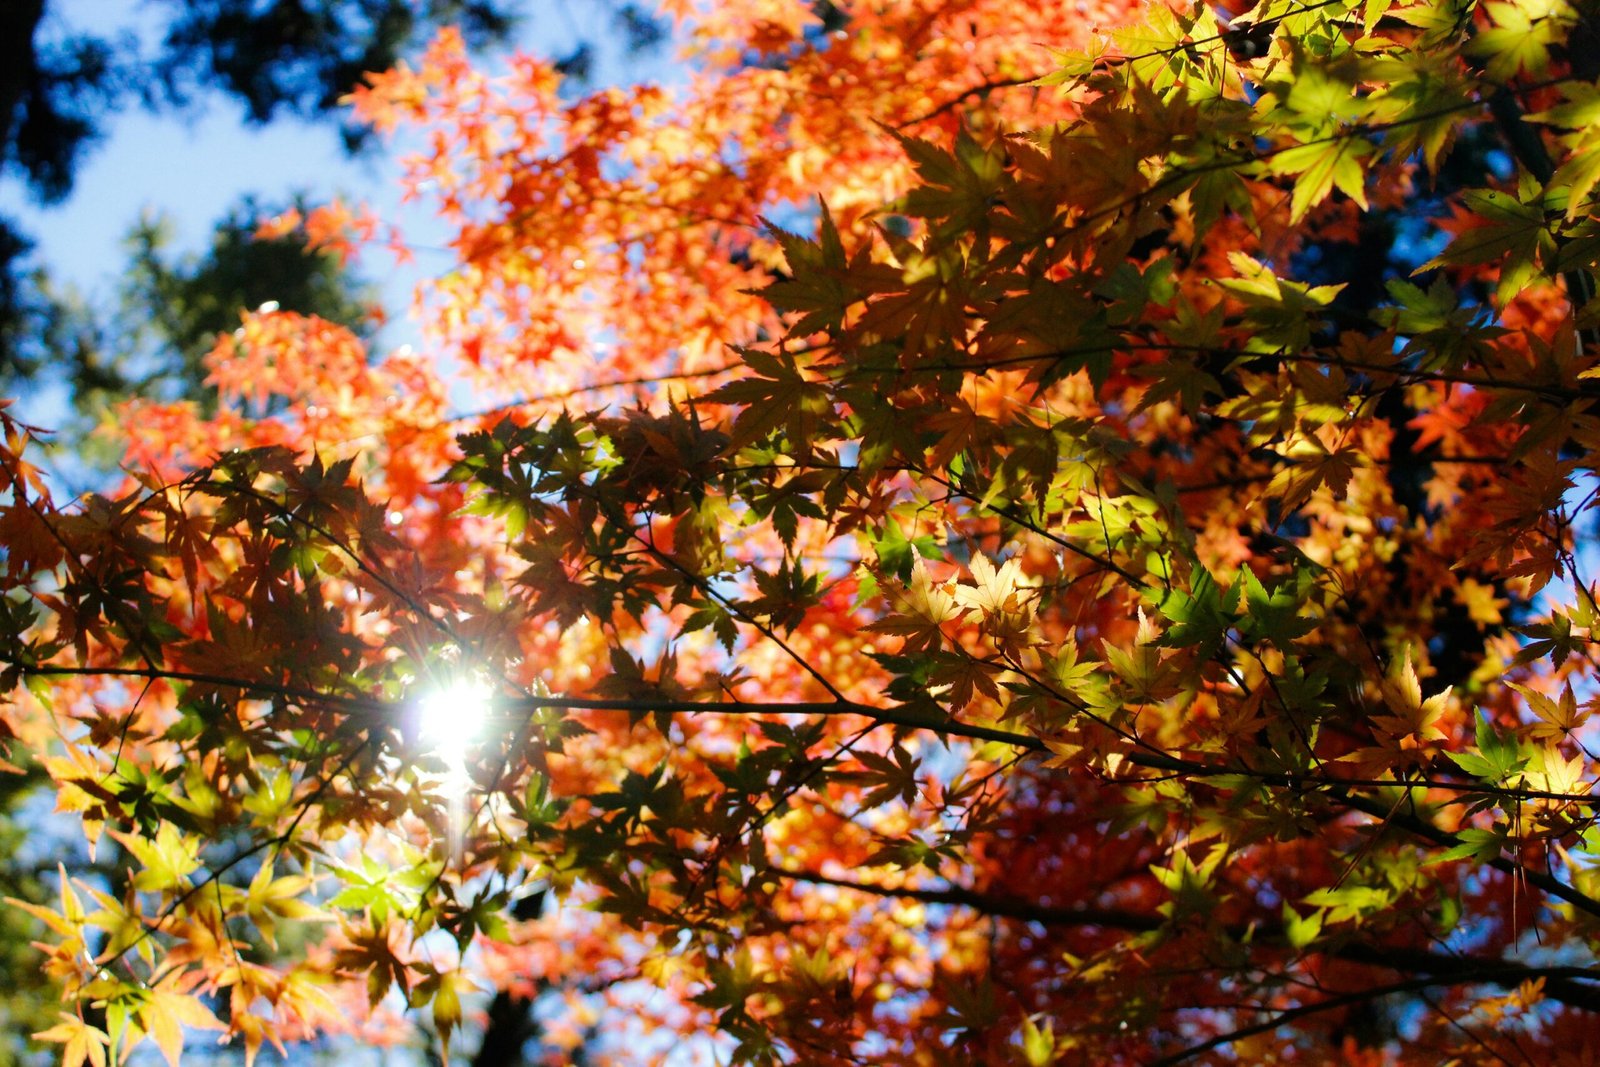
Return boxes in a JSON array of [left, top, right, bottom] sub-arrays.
[[0, 0, 1600, 1067]]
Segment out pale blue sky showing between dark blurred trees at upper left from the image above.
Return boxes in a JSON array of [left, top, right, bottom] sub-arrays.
[[0, 0, 686, 438]]
